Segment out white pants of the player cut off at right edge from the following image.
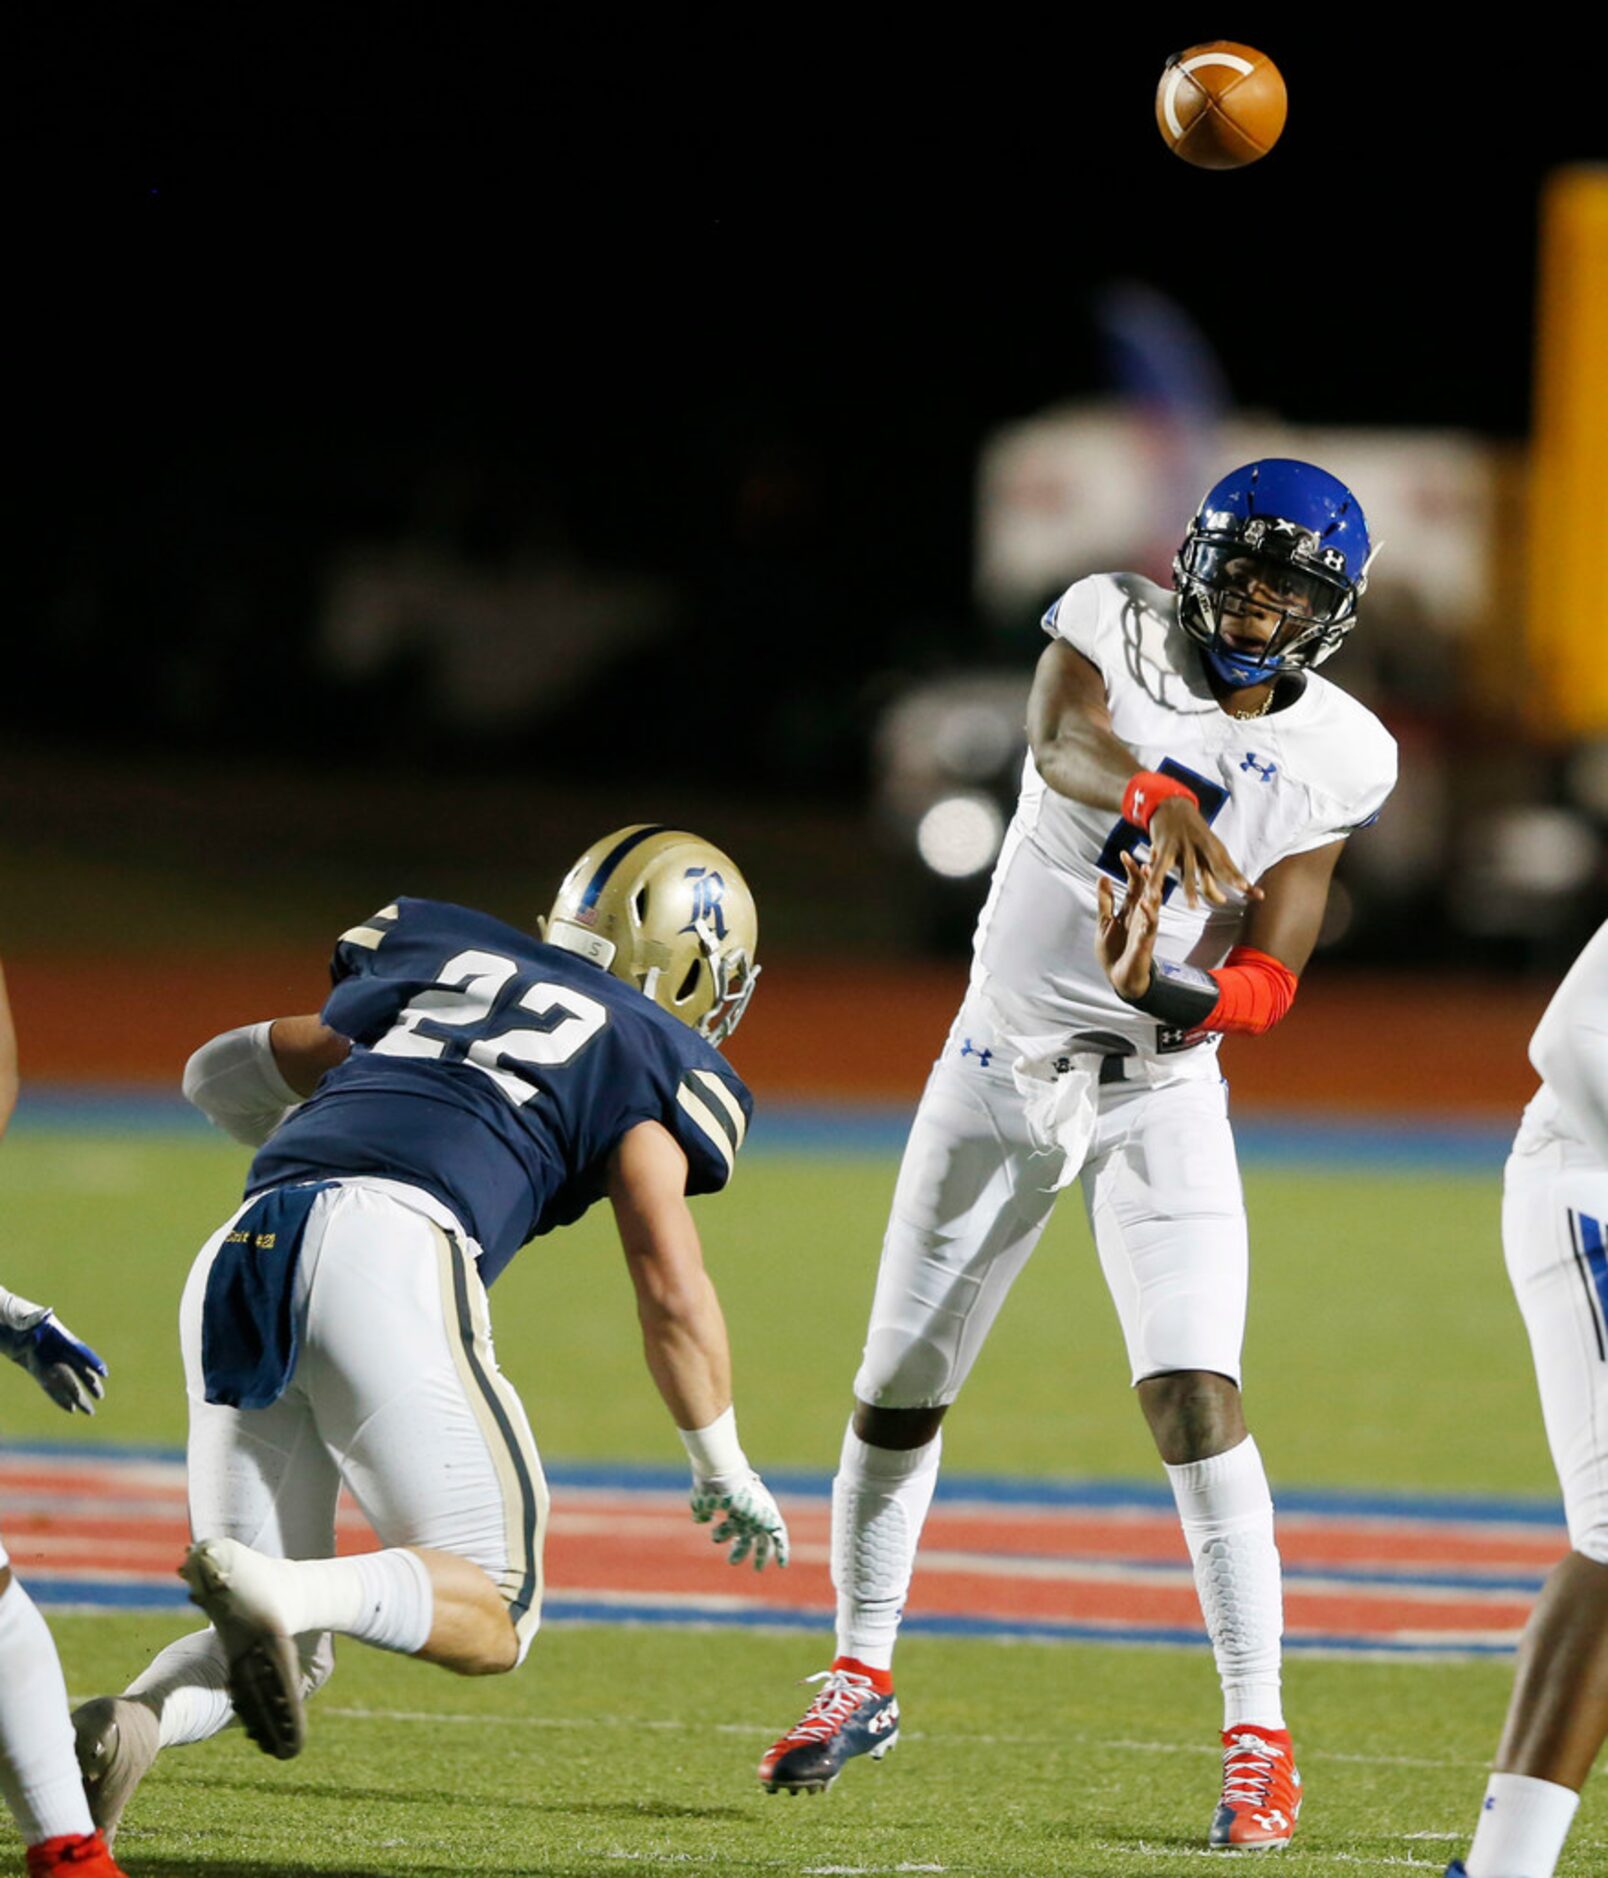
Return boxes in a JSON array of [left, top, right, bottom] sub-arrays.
[[1503, 1131, 1608, 1564]]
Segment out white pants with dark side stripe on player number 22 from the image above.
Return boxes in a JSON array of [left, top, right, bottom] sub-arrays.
[[178, 1179, 547, 1656]]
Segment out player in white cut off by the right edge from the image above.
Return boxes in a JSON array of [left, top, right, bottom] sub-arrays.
[[1448, 924, 1608, 1878]]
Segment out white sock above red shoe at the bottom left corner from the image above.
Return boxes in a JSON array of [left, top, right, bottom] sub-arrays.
[[0, 1578, 94, 1846]]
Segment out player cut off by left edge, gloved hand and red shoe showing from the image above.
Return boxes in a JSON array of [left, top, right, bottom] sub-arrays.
[[0, 973, 122, 1878]]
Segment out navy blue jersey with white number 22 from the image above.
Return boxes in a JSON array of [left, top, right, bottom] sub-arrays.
[[246, 900, 753, 1283]]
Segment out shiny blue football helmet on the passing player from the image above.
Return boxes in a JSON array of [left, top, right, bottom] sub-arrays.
[[1172, 456, 1373, 689]]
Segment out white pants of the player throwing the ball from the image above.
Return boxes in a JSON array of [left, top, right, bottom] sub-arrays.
[[855, 1001, 1249, 1409]]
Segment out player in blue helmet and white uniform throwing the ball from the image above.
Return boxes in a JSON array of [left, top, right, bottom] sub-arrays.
[[759, 460, 1396, 1846]]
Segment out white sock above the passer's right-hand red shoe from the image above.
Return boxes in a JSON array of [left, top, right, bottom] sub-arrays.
[[1167, 1435, 1285, 1730]]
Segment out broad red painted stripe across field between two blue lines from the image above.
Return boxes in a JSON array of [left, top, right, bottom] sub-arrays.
[[0, 1465, 1567, 1639]]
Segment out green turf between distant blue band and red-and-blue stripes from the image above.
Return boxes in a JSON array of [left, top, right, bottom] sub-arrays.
[[0, 1132, 1552, 1491]]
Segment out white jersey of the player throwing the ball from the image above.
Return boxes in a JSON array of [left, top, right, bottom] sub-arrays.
[[971, 575, 1396, 1055]]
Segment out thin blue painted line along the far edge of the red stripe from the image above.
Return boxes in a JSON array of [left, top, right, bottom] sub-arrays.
[[0, 1440, 1563, 1527]]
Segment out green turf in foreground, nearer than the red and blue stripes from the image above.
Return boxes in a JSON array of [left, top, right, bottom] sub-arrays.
[[56, 1617, 1608, 1878]]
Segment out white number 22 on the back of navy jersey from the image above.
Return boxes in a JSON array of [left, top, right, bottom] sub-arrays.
[[374, 952, 609, 1106]]
